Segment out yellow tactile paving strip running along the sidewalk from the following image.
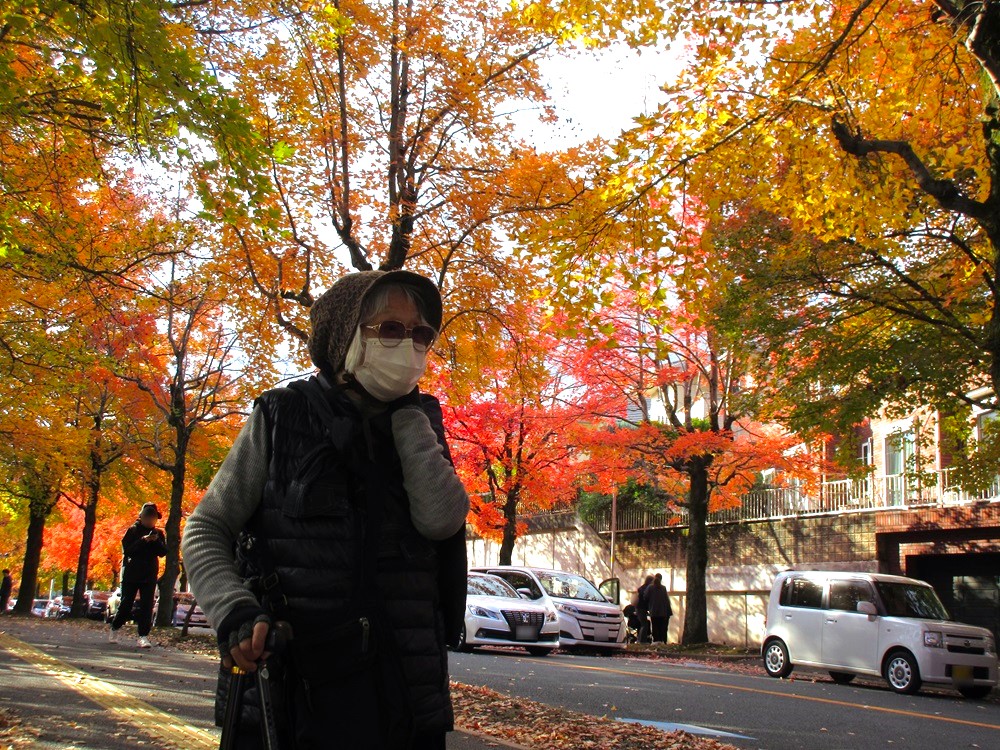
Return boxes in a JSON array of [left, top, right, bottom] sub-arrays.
[[0, 633, 219, 750]]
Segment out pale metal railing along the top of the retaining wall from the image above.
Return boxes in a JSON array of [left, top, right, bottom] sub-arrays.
[[595, 468, 1000, 532]]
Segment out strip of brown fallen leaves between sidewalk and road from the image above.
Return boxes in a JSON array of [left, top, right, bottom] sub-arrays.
[[451, 682, 735, 750]]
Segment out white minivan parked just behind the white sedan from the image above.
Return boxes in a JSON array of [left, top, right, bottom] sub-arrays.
[[471, 565, 625, 651]]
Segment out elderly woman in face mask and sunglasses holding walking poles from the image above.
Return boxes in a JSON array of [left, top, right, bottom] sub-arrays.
[[183, 271, 469, 750]]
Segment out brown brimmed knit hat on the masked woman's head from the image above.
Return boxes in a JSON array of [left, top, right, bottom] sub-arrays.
[[309, 271, 442, 375]]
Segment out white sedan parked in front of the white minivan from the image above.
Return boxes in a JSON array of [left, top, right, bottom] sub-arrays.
[[459, 573, 559, 656]]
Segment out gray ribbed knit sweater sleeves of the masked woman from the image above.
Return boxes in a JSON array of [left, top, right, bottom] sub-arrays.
[[181, 406, 469, 627]]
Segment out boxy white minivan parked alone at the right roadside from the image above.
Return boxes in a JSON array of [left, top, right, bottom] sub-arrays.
[[761, 571, 997, 698]]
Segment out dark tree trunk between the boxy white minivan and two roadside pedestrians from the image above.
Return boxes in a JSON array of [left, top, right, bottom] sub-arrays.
[[681, 460, 708, 646]]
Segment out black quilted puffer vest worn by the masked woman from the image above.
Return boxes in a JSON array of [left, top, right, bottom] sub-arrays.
[[233, 380, 465, 744]]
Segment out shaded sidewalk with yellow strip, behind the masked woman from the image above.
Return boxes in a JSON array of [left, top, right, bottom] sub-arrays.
[[0, 617, 517, 750]]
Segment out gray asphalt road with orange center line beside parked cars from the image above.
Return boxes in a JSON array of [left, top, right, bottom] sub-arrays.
[[451, 650, 1000, 750]]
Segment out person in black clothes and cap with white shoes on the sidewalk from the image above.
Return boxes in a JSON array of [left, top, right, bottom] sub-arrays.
[[108, 503, 167, 648]]
